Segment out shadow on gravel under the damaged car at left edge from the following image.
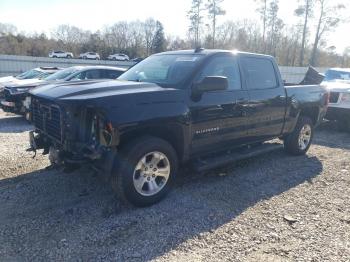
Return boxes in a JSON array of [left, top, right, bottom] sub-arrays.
[[0, 116, 33, 133]]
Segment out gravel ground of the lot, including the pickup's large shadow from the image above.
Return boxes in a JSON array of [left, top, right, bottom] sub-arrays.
[[0, 109, 350, 261]]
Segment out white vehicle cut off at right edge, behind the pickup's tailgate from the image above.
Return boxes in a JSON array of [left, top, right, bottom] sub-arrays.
[[323, 68, 350, 131]]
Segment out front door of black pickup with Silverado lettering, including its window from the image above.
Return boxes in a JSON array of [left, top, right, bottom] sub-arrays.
[[190, 54, 249, 155]]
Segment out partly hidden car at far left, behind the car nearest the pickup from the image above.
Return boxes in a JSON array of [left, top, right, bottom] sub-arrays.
[[0, 67, 60, 100]]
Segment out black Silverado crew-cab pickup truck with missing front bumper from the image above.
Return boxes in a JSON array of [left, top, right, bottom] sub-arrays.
[[30, 49, 328, 206]]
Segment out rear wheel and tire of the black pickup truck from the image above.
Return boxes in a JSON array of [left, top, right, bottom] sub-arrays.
[[284, 116, 314, 156]]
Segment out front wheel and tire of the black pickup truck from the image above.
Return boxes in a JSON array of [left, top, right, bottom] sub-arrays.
[[111, 136, 178, 207]]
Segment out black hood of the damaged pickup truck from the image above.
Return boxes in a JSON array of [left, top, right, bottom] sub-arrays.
[[30, 80, 182, 103]]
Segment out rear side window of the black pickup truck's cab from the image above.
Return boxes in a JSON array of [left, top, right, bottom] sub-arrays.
[[242, 57, 277, 89]]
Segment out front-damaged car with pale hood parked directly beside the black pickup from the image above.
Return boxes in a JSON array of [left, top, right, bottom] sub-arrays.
[[0, 66, 126, 118]]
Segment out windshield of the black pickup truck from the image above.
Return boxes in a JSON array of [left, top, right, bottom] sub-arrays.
[[118, 54, 204, 85]]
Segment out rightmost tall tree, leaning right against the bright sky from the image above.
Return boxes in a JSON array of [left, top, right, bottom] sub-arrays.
[[310, 0, 345, 66]]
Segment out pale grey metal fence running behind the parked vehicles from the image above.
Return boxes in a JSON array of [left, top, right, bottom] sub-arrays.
[[0, 55, 326, 83]]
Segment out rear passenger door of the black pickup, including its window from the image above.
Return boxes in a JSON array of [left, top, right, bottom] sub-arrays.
[[240, 55, 287, 142]]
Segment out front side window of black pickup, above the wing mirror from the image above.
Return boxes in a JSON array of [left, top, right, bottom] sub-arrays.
[[198, 56, 241, 90]]
